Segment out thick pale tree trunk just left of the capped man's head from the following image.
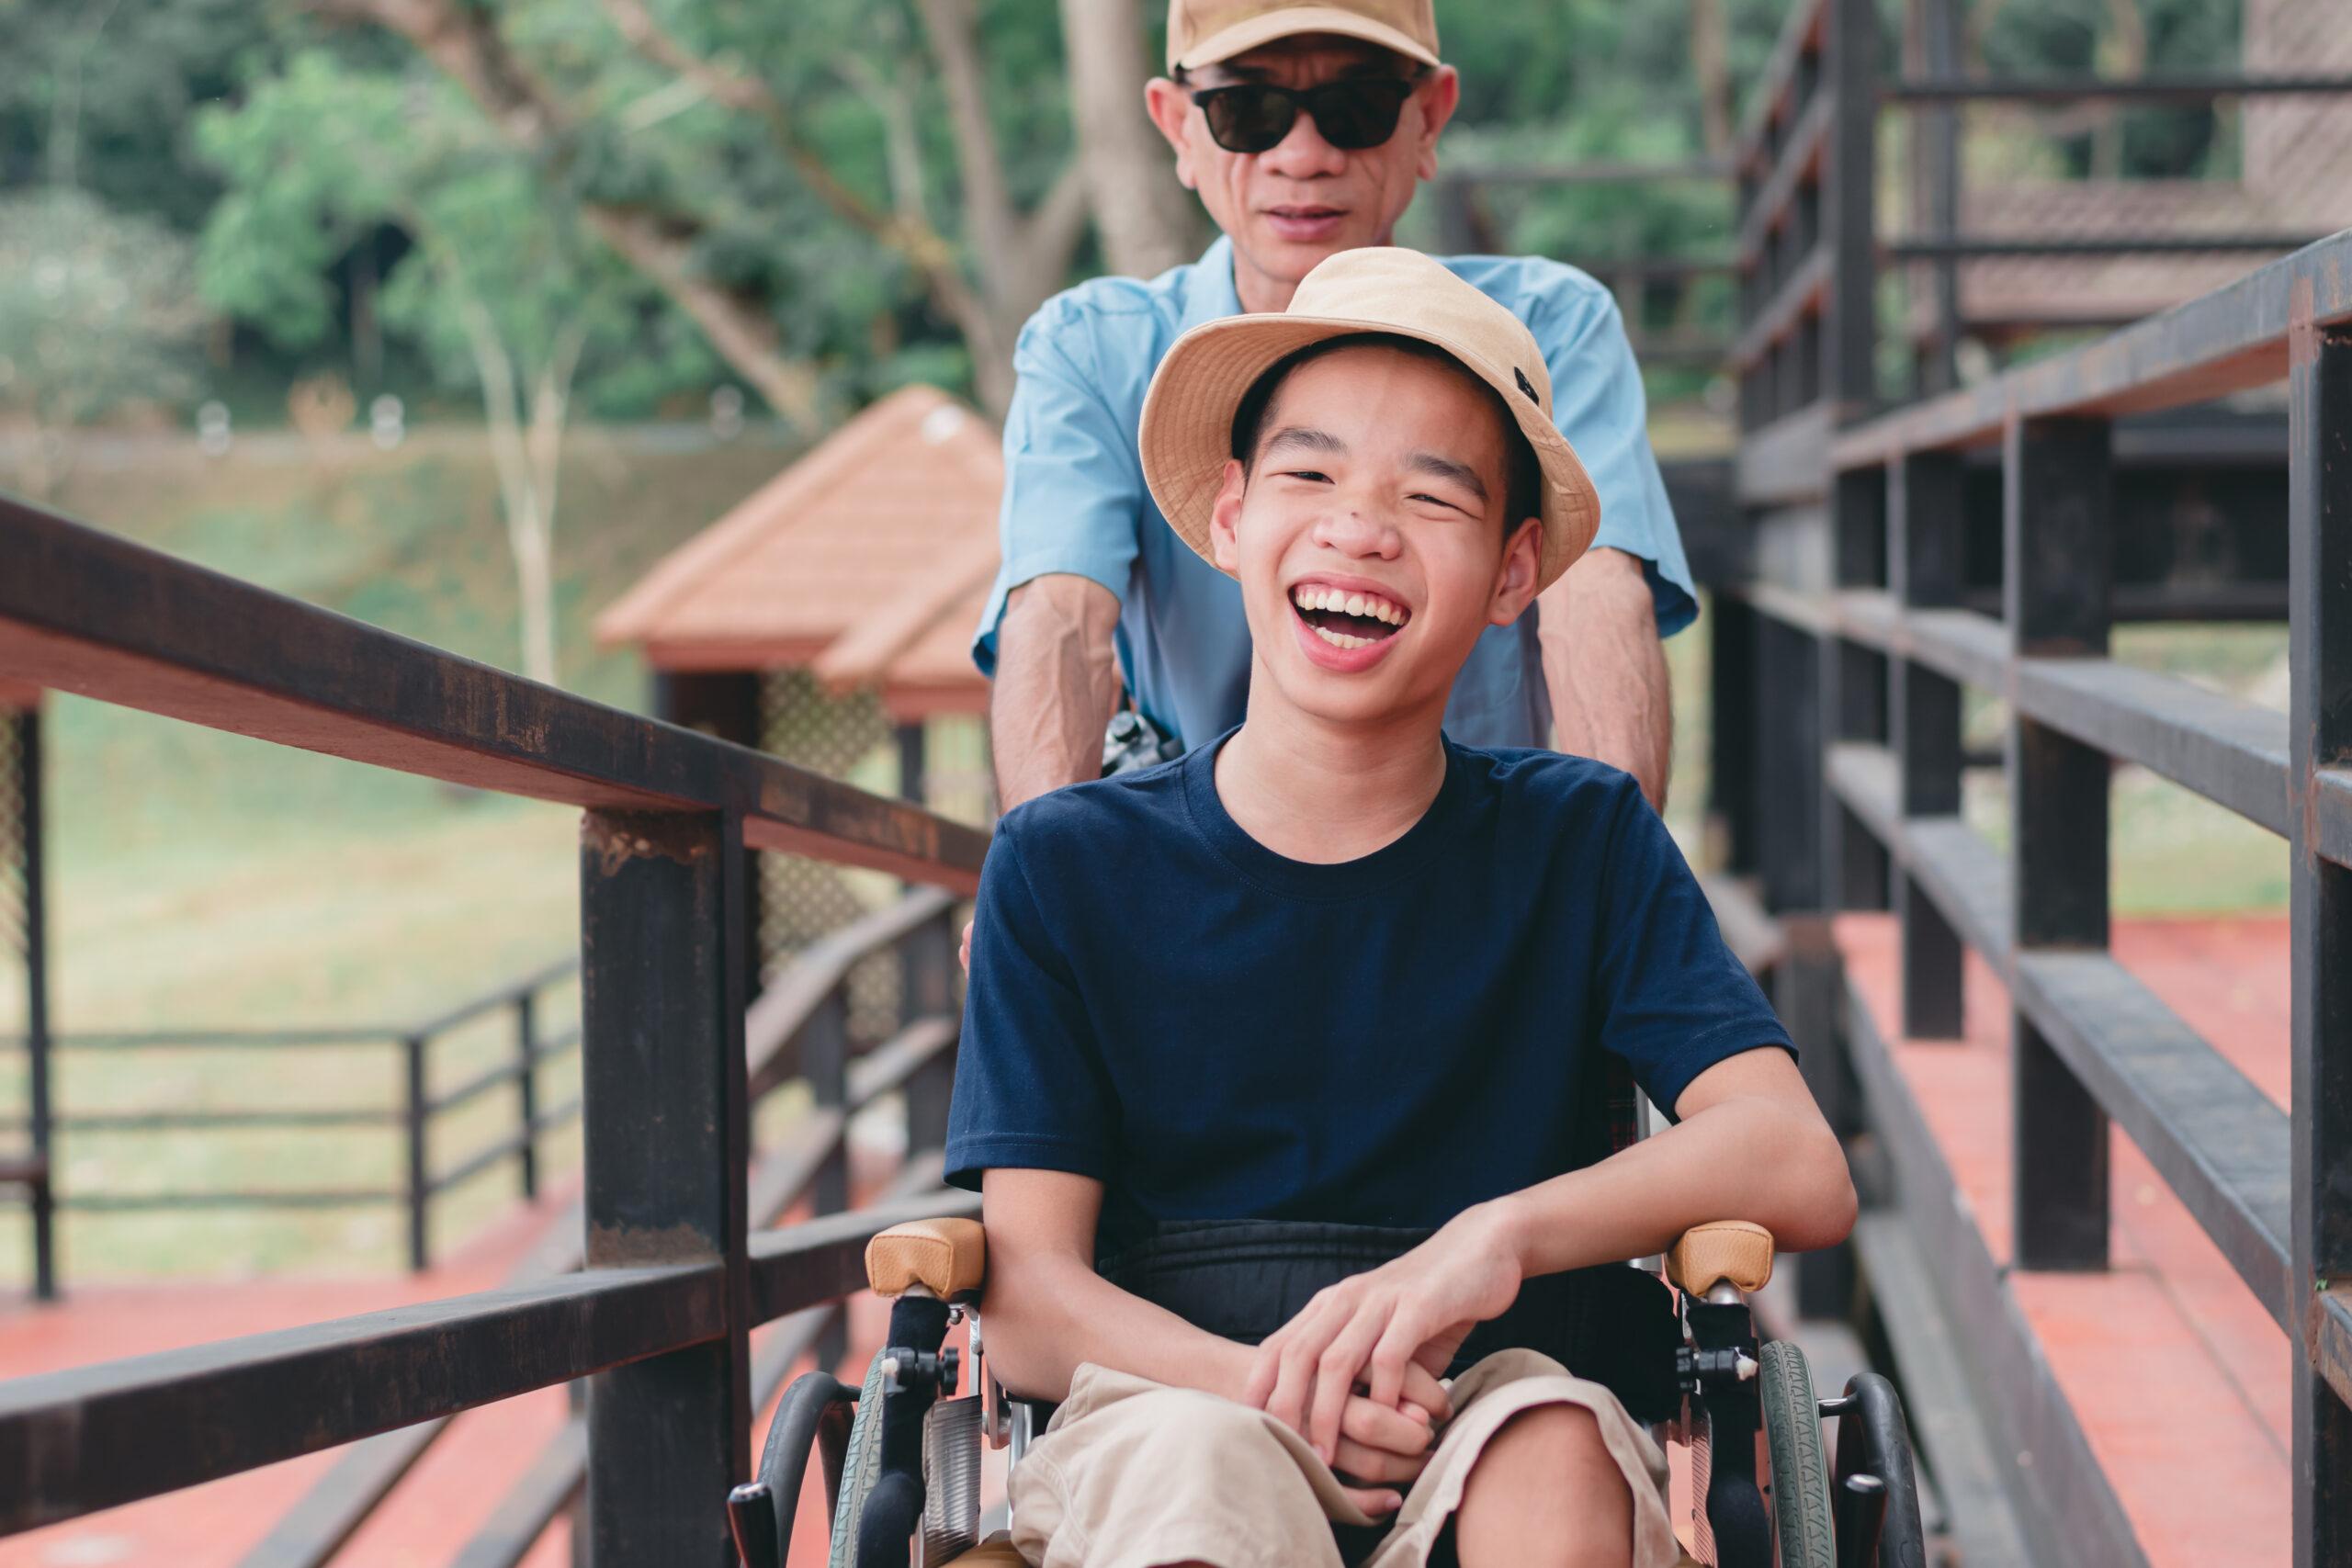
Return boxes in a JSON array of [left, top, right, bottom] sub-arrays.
[[1061, 0, 1202, 277]]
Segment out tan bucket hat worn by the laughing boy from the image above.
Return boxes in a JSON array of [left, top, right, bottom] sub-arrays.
[[1138, 244, 1601, 592]]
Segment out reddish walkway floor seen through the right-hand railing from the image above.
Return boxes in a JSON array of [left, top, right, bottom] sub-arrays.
[[1837, 915, 2293, 1568]]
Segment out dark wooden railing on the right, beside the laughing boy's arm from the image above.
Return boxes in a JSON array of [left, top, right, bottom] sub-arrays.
[[1717, 231, 2352, 1563]]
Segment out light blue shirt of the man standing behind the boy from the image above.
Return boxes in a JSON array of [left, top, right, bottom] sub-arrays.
[[971, 237, 1698, 748]]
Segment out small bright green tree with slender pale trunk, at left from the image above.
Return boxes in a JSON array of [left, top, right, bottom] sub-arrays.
[[198, 51, 715, 682]]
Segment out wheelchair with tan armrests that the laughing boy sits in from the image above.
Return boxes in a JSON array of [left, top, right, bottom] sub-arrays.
[[727, 1220, 1927, 1568]]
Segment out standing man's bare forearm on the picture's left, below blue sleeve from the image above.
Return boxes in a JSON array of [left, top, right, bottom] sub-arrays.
[[988, 573, 1120, 811]]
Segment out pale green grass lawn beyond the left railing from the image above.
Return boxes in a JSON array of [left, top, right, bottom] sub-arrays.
[[0, 430, 790, 1283]]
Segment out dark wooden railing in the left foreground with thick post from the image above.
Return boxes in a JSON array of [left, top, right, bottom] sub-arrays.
[[0, 491, 986, 1568]]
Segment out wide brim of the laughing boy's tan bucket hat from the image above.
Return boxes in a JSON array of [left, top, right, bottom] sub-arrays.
[[1136, 312, 1601, 592]]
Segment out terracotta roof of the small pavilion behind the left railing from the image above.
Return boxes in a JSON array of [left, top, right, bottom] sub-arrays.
[[595, 386, 1004, 680]]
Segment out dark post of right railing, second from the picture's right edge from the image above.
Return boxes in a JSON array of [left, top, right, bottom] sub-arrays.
[[2002, 421, 2114, 1269]]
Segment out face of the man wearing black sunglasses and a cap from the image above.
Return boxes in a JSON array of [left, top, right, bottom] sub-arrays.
[[1146, 33, 1461, 310]]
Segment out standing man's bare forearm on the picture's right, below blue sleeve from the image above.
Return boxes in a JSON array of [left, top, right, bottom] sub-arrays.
[[1538, 547, 1675, 811]]
